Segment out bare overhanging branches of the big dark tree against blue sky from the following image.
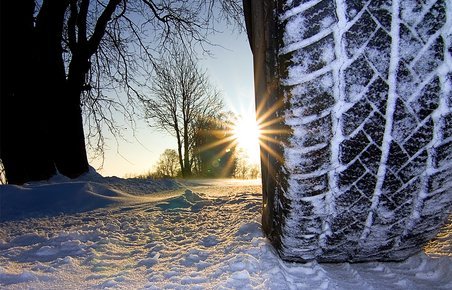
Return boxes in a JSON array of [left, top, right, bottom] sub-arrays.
[[72, 0, 243, 163]]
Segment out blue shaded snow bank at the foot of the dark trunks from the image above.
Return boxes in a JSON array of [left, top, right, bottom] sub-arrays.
[[0, 168, 181, 222]]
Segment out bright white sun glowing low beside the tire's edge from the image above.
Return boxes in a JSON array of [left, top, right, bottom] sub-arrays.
[[232, 117, 261, 163]]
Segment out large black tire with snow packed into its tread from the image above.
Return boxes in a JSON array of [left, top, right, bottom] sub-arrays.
[[247, 0, 452, 262]]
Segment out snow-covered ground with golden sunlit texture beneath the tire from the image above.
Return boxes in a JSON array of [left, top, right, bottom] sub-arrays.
[[0, 174, 452, 290]]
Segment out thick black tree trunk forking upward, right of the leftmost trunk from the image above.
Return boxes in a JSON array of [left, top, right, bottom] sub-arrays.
[[36, 1, 88, 178]]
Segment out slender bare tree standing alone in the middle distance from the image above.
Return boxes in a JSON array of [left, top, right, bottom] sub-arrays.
[[143, 50, 223, 177]]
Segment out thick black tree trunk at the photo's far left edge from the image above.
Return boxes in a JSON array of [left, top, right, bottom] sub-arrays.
[[0, 1, 55, 184]]
